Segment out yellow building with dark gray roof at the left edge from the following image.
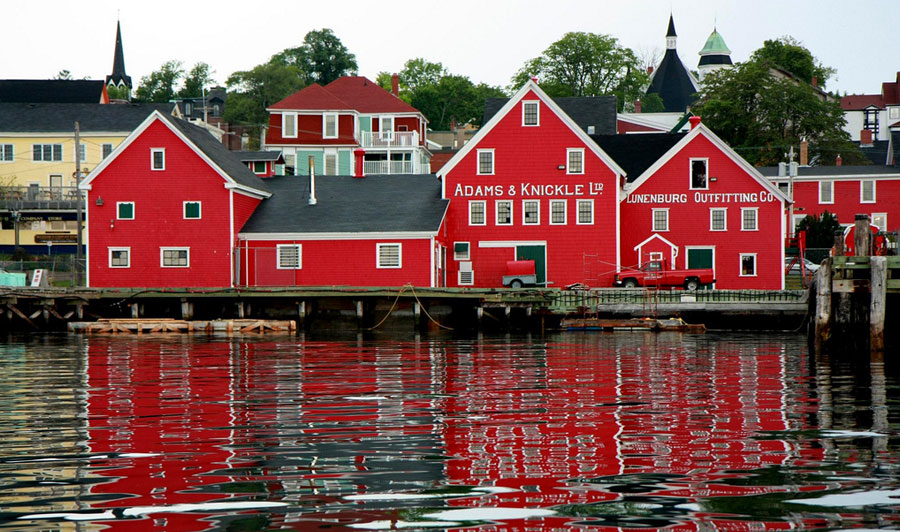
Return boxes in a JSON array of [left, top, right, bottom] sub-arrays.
[[0, 103, 177, 254]]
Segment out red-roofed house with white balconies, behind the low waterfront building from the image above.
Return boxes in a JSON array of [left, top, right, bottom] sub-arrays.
[[263, 76, 431, 176]]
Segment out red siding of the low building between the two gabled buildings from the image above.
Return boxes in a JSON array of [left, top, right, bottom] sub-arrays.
[[240, 237, 432, 286]]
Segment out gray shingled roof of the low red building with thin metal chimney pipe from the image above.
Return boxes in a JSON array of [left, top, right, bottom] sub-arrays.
[[241, 175, 449, 234]]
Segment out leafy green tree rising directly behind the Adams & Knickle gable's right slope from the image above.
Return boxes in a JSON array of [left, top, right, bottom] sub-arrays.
[[511, 32, 649, 110]]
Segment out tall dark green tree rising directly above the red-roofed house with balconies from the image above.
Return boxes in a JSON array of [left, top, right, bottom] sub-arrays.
[[269, 28, 357, 86]]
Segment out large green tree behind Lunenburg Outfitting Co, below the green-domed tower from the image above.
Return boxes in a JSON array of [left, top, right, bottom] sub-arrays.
[[692, 61, 866, 165]]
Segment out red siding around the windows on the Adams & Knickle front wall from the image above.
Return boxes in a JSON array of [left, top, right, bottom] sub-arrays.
[[444, 93, 618, 287]]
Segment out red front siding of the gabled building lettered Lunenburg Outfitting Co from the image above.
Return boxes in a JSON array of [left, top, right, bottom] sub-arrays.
[[622, 135, 784, 290]]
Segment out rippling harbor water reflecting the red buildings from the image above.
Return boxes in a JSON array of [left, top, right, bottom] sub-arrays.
[[0, 332, 900, 532]]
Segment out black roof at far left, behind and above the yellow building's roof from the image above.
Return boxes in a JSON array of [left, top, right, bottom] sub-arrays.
[[0, 80, 104, 103]]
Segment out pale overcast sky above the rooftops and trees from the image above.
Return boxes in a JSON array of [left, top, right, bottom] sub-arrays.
[[7, 0, 900, 94]]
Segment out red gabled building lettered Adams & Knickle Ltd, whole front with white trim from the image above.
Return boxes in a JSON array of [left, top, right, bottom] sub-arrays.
[[437, 81, 624, 287]]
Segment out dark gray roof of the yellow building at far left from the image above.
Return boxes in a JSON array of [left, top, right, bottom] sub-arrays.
[[0, 103, 175, 134]]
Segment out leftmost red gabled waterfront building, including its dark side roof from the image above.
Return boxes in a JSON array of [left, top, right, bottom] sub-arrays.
[[81, 112, 270, 287]]
